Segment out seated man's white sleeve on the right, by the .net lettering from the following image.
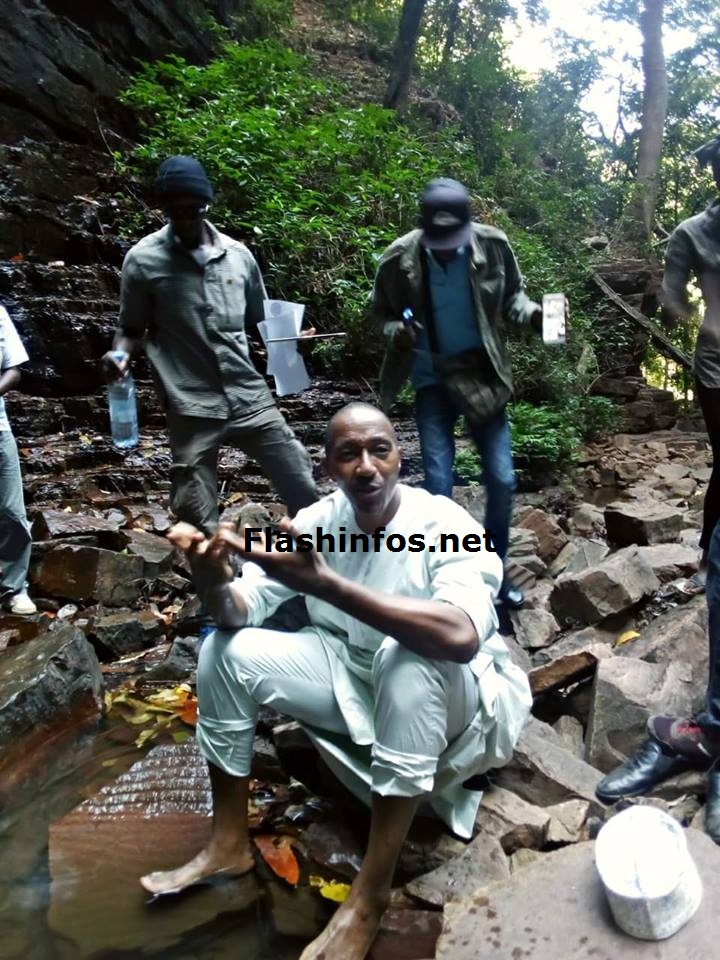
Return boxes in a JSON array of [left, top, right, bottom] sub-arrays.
[[427, 502, 503, 647]]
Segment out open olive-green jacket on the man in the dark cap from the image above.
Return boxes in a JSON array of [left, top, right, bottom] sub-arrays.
[[371, 223, 540, 411]]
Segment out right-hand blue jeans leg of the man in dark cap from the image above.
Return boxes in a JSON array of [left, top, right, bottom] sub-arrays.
[[470, 410, 516, 561]]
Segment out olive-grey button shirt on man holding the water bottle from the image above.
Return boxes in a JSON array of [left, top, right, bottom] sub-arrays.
[[119, 227, 274, 421]]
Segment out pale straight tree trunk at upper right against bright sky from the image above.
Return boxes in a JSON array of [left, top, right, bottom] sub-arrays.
[[629, 0, 668, 239]]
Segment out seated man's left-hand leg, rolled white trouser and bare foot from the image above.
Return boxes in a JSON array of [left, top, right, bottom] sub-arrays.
[[141, 627, 347, 893]]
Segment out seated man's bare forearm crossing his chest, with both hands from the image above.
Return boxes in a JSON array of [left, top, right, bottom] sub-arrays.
[[168, 520, 478, 663]]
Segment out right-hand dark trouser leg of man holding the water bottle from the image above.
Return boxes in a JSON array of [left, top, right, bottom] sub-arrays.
[[229, 410, 318, 516]]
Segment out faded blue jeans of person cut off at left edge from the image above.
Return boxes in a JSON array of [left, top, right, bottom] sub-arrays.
[[0, 430, 32, 595]]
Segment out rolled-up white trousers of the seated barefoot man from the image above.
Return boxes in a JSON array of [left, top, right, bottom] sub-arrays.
[[197, 627, 480, 796]]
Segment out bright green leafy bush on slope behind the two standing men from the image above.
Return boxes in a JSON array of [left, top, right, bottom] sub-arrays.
[[119, 40, 475, 372]]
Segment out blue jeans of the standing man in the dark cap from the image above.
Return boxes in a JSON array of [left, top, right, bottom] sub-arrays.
[[415, 385, 516, 560]]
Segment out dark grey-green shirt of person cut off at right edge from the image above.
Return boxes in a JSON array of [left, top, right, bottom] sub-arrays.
[[663, 200, 720, 390]]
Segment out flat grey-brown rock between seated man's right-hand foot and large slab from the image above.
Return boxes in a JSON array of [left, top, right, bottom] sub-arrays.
[[405, 832, 510, 908]]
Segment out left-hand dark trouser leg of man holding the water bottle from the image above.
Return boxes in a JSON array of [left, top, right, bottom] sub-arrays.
[[168, 413, 226, 535]]
